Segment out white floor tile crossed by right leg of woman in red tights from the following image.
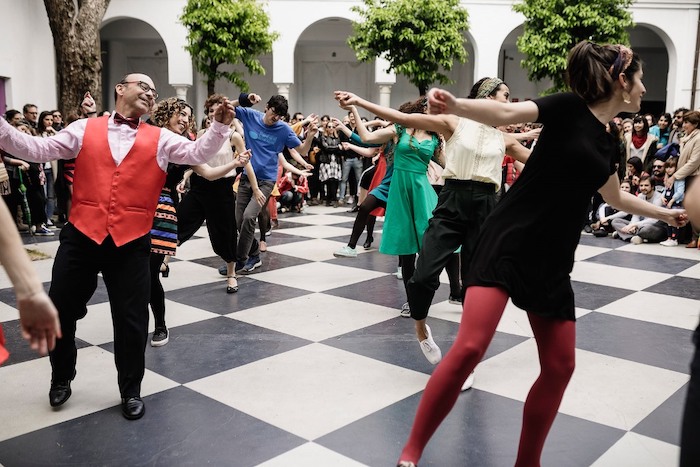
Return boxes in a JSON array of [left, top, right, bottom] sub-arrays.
[[474, 339, 688, 430]]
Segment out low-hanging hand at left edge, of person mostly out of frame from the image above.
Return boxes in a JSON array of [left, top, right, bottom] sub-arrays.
[[17, 290, 62, 355]]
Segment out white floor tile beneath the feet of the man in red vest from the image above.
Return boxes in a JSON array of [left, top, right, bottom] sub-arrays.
[[0, 347, 178, 441]]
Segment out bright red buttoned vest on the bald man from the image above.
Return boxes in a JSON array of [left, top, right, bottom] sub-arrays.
[[70, 117, 165, 246]]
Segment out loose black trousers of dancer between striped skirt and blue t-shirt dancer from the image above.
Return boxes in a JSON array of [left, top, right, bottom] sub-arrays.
[[177, 175, 238, 263]]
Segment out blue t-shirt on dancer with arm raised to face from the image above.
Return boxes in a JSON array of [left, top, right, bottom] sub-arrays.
[[236, 107, 301, 181]]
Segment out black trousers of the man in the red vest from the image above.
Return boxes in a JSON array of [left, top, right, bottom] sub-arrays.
[[49, 223, 151, 397]]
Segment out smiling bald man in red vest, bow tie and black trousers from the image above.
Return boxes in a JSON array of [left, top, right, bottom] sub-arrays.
[[0, 73, 234, 420]]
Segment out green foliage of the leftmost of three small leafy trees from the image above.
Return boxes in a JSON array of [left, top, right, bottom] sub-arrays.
[[180, 0, 279, 94]]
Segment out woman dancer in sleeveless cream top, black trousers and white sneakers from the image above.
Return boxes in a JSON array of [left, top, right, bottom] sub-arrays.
[[335, 78, 530, 370]]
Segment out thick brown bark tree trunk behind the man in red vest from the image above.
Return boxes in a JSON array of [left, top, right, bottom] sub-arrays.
[[44, 0, 110, 120]]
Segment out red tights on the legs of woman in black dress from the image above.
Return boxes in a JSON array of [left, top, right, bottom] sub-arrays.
[[401, 287, 576, 467]]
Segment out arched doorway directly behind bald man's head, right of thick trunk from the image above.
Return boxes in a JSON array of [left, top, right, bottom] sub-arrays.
[[100, 18, 170, 110]]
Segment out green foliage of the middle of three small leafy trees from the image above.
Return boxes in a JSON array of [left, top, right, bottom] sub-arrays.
[[348, 0, 468, 94]]
